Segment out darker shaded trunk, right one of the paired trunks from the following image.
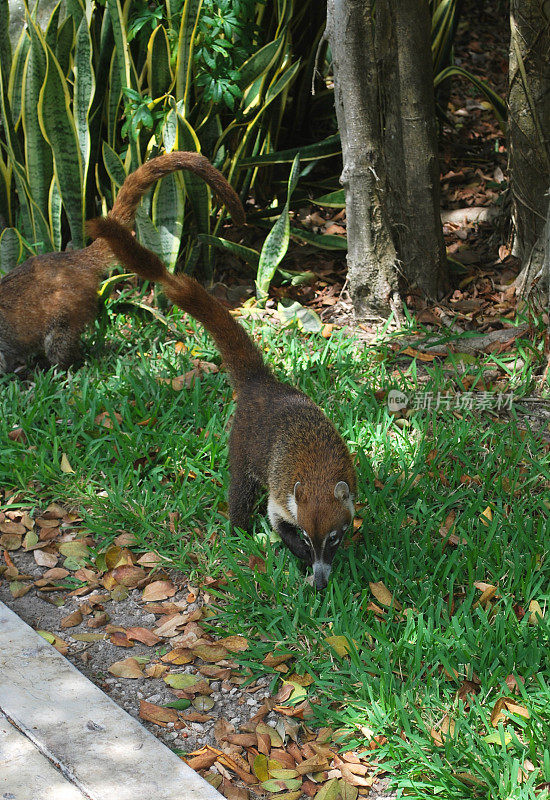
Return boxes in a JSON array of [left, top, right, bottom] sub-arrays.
[[387, 0, 447, 298]]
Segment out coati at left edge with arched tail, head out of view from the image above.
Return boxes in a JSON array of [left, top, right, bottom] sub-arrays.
[[0, 151, 245, 375]]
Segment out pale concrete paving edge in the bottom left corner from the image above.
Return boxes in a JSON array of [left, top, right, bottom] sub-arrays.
[[0, 603, 222, 800]]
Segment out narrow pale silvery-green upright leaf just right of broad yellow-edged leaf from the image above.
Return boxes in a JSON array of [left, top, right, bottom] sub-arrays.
[[73, 15, 95, 191]]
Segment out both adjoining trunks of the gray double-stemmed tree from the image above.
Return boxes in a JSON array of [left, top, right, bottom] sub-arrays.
[[327, 0, 446, 319]]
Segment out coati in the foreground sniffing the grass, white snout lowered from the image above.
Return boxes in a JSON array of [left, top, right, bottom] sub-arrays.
[[88, 217, 355, 589]]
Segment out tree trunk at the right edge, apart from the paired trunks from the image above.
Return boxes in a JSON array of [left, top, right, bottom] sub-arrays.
[[508, 0, 550, 293]]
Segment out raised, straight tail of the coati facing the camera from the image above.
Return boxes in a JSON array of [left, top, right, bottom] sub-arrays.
[[88, 216, 269, 392]]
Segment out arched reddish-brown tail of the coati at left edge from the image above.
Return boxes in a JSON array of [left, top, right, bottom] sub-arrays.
[[109, 150, 245, 227]]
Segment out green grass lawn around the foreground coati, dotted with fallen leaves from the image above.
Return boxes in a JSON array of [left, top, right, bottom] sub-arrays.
[[0, 304, 550, 800]]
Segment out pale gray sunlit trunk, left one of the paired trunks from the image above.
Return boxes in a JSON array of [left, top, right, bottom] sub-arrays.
[[327, 0, 399, 320]]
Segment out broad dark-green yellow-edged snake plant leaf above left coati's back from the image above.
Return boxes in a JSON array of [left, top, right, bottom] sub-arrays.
[[33, 21, 85, 249]]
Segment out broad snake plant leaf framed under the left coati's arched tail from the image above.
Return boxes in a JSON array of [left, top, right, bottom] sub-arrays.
[[151, 173, 185, 272]]
